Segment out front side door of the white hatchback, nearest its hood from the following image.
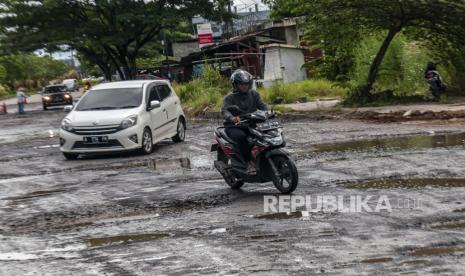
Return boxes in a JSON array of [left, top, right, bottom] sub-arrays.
[[147, 85, 168, 141]]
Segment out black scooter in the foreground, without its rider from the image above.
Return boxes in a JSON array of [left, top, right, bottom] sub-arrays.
[[211, 106, 299, 194]]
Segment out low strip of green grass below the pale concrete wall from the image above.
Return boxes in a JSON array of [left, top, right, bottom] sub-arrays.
[[259, 79, 347, 103]]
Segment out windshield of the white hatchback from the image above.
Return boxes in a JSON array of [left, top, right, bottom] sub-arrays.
[[76, 88, 142, 111]]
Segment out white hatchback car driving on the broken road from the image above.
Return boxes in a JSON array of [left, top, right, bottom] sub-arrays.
[[60, 80, 186, 159]]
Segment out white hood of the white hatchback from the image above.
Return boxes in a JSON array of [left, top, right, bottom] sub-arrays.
[[66, 108, 139, 126]]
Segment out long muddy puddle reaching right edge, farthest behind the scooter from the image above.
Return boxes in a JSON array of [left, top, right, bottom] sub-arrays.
[[314, 133, 465, 153]]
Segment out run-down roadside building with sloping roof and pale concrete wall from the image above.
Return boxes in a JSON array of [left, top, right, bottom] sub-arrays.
[[179, 18, 321, 85]]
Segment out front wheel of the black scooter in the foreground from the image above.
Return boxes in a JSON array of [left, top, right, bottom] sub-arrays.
[[272, 155, 299, 194]]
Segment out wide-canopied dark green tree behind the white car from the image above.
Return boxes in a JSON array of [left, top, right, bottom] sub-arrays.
[[0, 0, 229, 79]]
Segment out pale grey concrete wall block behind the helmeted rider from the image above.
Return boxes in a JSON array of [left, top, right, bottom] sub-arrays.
[[263, 46, 307, 87]]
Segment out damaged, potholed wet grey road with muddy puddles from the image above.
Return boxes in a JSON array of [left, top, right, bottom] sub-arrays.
[[0, 111, 465, 275]]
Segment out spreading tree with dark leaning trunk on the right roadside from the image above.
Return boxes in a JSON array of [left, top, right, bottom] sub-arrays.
[[269, 0, 465, 98]]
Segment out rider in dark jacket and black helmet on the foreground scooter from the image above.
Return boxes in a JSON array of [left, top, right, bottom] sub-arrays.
[[221, 69, 269, 175]]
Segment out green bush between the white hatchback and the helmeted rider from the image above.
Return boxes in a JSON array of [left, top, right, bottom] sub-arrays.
[[174, 64, 231, 115]]
